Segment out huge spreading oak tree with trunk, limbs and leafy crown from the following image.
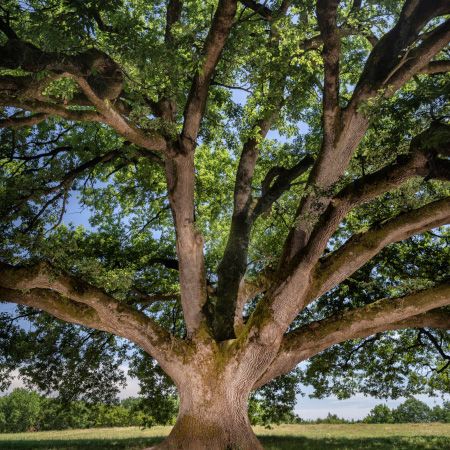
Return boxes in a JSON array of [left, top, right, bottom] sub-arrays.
[[0, 0, 450, 450]]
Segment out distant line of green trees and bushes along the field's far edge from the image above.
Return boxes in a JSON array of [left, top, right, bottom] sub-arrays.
[[0, 388, 450, 433]]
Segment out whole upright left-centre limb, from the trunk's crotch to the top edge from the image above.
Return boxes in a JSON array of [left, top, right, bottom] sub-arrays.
[[166, 0, 237, 336]]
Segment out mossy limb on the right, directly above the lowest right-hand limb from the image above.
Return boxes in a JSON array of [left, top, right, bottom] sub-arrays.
[[242, 197, 450, 362]]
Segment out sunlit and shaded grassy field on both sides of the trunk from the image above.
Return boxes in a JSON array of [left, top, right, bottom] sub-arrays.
[[0, 423, 450, 450]]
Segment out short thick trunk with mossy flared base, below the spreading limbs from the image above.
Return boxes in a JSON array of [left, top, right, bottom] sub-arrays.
[[147, 373, 262, 450]]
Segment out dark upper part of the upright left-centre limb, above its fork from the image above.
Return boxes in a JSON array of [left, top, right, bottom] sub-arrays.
[[181, 0, 237, 150]]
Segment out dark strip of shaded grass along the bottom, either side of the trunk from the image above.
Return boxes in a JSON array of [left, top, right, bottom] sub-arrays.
[[0, 436, 450, 450]]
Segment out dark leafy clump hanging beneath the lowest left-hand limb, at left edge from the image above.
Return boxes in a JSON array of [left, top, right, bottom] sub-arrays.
[[0, 308, 126, 403]]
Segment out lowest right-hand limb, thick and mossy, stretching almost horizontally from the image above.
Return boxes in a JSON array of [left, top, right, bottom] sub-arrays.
[[254, 283, 450, 389]]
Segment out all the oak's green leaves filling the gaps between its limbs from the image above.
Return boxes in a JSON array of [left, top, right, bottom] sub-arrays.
[[0, 0, 450, 427]]
